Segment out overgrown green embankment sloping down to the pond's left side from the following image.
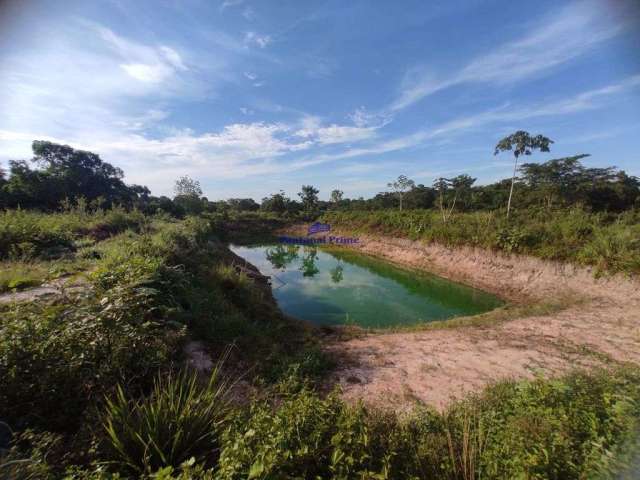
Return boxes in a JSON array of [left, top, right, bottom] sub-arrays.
[[0, 213, 319, 473]]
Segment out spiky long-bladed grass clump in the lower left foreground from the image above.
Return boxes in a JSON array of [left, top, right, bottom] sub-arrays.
[[103, 368, 234, 474]]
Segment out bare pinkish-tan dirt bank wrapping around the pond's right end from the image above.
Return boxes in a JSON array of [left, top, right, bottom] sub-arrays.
[[284, 227, 640, 409]]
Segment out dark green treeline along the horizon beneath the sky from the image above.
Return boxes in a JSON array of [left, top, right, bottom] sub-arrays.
[[0, 141, 640, 217]]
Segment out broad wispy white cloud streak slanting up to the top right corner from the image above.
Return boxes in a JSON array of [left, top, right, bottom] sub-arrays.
[[390, 1, 625, 111]]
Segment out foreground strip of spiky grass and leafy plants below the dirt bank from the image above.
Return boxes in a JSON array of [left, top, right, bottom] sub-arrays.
[[4, 367, 640, 480]]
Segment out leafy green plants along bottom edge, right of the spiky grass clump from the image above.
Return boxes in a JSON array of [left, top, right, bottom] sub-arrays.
[[218, 369, 640, 479]]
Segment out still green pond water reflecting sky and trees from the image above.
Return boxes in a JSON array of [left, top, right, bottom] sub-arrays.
[[230, 244, 502, 328]]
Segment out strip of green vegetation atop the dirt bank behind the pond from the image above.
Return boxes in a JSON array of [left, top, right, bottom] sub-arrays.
[[322, 208, 640, 274]]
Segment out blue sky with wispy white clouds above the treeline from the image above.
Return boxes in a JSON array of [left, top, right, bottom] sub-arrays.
[[0, 0, 640, 201]]
